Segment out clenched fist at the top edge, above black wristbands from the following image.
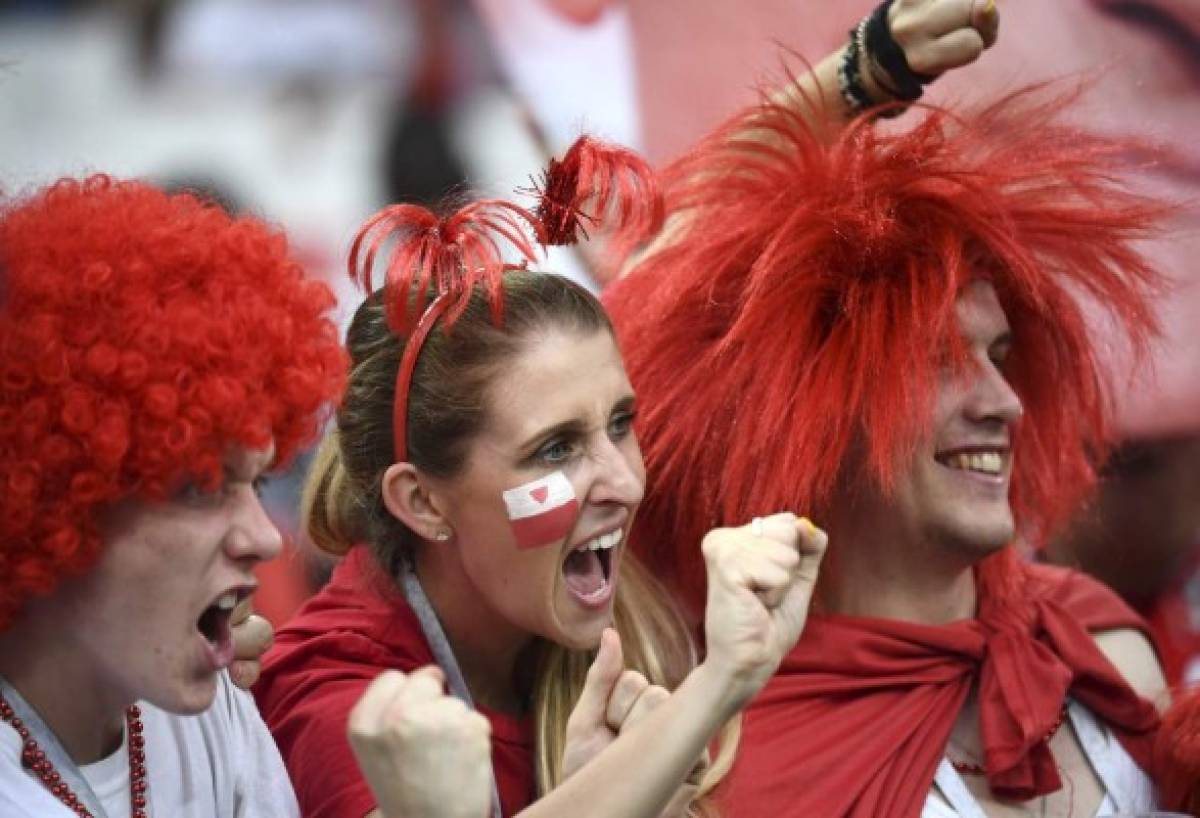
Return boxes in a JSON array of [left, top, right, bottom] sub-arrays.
[[888, 0, 1000, 77]]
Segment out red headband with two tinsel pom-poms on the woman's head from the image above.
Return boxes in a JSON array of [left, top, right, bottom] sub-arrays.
[[348, 137, 662, 461]]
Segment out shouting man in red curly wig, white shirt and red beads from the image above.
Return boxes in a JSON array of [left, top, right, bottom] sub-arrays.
[[0, 176, 344, 818]]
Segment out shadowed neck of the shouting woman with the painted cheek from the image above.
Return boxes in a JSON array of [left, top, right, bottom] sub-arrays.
[[416, 548, 534, 715]]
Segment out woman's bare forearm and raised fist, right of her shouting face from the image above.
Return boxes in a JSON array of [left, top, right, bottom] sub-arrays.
[[520, 515, 828, 818]]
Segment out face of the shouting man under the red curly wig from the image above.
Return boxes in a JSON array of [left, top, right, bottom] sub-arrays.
[[56, 451, 283, 714]]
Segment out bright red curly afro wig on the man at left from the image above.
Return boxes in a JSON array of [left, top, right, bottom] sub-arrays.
[[0, 175, 346, 630]]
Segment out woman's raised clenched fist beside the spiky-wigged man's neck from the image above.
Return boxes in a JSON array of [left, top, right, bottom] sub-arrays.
[[700, 513, 829, 714]]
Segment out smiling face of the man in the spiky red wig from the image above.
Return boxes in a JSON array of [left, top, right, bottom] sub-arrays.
[[853, 281, 1021, 563]]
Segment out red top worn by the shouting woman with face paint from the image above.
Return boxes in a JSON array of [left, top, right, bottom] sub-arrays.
[[254, 547, 535, 818]]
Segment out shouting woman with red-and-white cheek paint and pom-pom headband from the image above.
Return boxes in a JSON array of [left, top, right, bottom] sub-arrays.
[[257, 148, 824, 818]]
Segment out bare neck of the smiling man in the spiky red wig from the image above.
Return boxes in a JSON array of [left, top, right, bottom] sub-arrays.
[[821, 506, 977, 625]]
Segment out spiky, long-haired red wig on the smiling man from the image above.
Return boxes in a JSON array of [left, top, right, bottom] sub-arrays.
[[605, 91, 1163, 605]]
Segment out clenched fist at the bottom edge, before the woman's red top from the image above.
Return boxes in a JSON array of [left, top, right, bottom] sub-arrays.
[[347, 666, 492, 818]]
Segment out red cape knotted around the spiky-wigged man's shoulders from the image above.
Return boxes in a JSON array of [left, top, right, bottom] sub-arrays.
[[726, 566, 1159, 818]]
